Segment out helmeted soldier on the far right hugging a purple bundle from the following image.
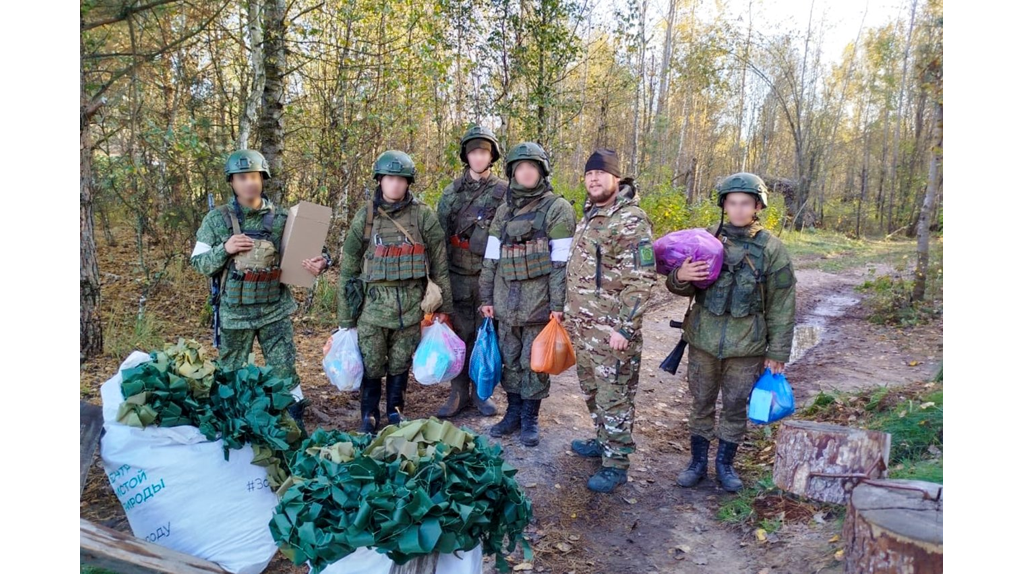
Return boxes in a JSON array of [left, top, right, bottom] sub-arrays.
[[666, 173, 797, 492]]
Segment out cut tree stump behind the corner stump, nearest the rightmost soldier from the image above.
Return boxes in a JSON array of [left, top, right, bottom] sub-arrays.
[[772, 421, 892, 504]]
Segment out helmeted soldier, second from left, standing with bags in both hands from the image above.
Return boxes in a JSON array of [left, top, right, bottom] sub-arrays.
[[338, 150, 452, 433]]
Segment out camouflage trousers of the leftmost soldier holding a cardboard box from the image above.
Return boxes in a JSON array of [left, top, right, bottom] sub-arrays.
[[217, 317, 302, 399]]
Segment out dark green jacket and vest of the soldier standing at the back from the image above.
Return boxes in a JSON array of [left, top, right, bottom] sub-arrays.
[[437, 170, 508, 275]]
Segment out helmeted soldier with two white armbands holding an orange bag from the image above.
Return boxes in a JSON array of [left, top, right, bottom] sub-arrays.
[[480, 142, 575, 446]]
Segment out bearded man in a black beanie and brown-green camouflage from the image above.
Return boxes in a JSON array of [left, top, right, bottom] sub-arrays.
[[565, 149, 657, 492]]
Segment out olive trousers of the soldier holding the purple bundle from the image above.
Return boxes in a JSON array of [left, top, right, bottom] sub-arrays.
[[687, 345, 765, 443]]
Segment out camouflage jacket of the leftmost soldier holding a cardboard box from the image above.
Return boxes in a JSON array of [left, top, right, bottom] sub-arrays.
[[190, 198, 298, 329]]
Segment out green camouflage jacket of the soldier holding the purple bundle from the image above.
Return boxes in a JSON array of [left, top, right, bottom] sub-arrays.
[[666, 222, 797, 362]]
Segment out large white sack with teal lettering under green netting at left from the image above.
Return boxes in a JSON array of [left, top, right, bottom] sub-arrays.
[[100, 352, 278, 574]]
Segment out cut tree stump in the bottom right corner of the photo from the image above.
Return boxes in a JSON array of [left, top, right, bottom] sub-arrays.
[[843, 480, 942, 574]]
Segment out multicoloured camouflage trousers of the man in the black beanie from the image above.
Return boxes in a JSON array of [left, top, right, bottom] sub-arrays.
[[577, 350, 640, 471]]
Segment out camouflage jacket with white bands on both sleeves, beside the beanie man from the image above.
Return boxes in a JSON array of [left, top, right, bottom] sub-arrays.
[[479, 183, 575, 326]]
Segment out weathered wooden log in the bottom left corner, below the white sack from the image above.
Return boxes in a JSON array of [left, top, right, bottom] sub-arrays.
[[80, 519, 227, 574]]
